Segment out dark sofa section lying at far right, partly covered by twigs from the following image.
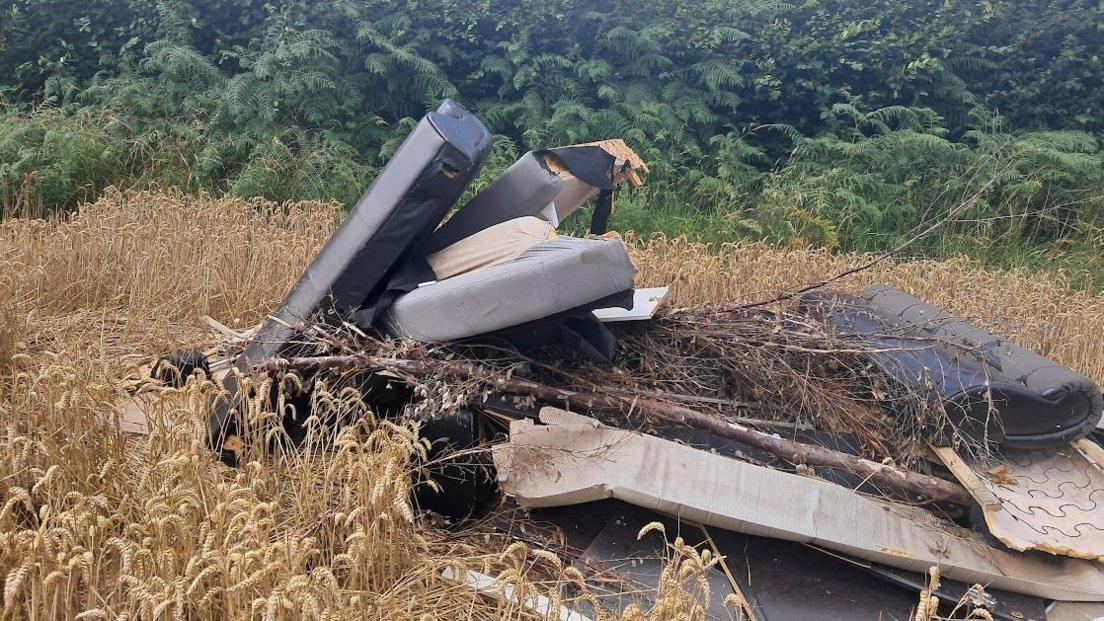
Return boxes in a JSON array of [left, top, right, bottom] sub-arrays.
[[802, 285, 1104, 449]]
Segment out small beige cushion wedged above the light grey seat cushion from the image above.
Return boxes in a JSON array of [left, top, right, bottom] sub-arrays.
[[426, 215, 555, 281]]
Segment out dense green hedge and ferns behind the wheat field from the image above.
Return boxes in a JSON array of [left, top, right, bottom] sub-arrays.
[[0, 0, 1104, 274]]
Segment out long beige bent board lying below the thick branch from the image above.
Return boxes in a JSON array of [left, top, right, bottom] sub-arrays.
[[493, 411, 1104, 601]]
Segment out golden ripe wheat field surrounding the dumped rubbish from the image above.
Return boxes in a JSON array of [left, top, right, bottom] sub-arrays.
[[0, 190, 1104, 621]]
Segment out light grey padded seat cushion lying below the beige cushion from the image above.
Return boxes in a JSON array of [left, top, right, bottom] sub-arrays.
[[385, 236, 636, 343]]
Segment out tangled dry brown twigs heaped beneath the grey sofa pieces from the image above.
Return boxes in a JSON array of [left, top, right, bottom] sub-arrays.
[[262, 306, 941, 463]]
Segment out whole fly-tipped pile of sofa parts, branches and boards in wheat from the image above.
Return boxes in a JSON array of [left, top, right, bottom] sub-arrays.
[[129, 101, 1104, 621]]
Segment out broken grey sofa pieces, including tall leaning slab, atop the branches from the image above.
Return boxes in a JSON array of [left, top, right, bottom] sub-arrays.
[[209, 101, 647, 457]]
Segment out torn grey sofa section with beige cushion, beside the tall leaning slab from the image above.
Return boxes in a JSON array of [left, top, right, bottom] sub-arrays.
[[379, 140, 647, 361]]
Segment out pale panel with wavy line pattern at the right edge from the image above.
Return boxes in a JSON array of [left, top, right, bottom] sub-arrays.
[[935, 444, 1104, 560]]
